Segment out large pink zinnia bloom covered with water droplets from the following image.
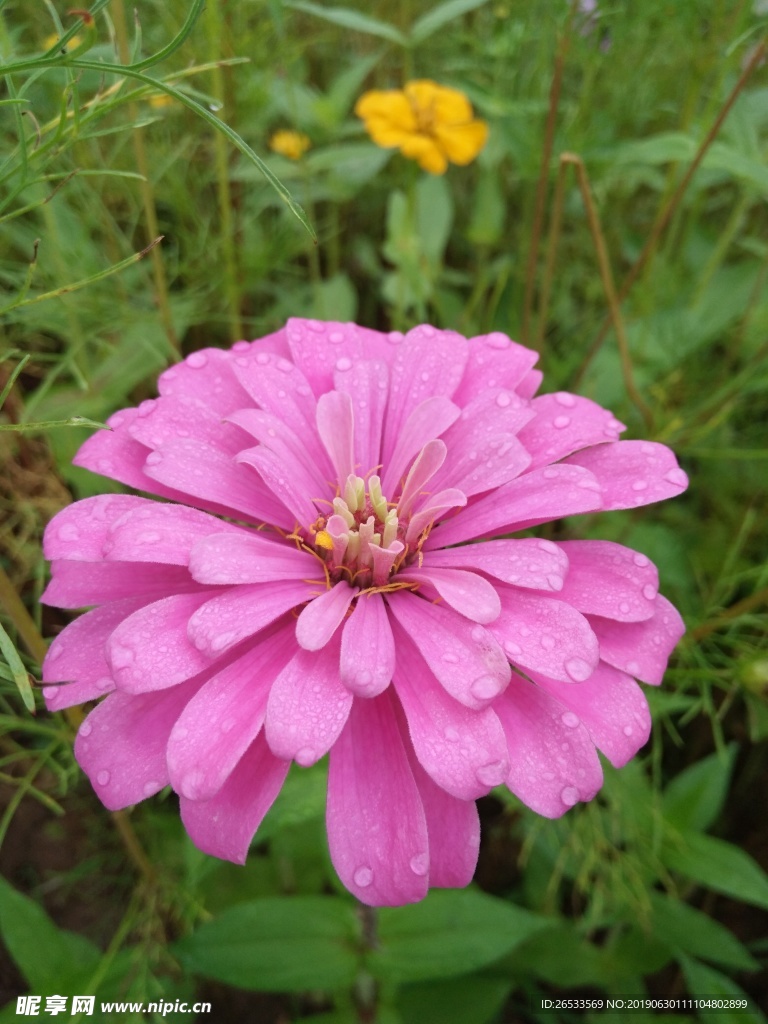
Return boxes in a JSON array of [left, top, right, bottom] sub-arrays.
[[44, 319, 687, 905]]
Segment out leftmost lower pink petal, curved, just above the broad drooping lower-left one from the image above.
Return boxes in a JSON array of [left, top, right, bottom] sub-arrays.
[[43, 598, 142, 711]]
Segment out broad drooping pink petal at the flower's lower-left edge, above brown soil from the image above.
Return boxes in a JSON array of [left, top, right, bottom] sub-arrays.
[[75, 679, 203, 811]]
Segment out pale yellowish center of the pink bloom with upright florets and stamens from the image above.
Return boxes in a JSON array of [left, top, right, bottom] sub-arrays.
[[309, 474, 421, 589]]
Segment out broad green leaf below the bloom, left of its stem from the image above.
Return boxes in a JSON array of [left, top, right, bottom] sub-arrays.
[[174, 896, 358, 992]]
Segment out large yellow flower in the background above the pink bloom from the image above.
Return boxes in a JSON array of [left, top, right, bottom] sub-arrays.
[[354, 79, 488, 174]]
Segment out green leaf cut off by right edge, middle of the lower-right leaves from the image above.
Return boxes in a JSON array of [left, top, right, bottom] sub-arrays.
[[662, 831, 768, 908]]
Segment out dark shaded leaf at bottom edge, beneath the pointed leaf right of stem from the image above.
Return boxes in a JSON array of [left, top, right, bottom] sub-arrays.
[[397, 978, 512, 1024]]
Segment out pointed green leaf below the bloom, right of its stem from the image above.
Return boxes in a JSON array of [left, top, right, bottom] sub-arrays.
[[368, 889, 548, 982]]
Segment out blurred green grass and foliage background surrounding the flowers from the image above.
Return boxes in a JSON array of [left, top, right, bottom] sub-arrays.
[[0, 0, 768, 1024]]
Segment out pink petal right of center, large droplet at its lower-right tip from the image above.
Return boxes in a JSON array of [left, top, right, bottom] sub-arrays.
[[488, 586, 599, 683]]
